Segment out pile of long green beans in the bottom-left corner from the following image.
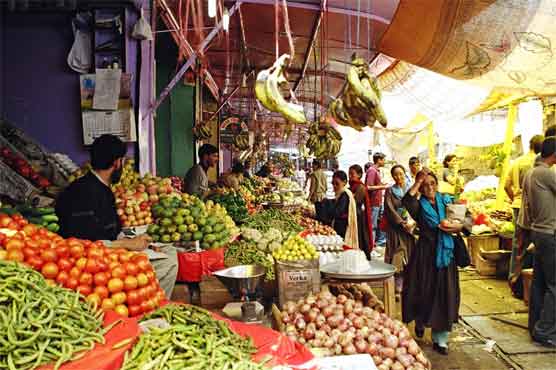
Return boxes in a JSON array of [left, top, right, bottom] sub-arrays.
[[0, 261, 104, 370]]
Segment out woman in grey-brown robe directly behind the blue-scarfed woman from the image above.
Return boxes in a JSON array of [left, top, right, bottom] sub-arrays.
[[384, 164, 415, 294]]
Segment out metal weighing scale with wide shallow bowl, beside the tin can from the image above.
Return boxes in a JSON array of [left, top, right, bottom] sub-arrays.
[[213, 265, 265, 324]]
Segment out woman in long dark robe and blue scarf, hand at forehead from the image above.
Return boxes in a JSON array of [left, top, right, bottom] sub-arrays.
[[402, 168, 472, 355]]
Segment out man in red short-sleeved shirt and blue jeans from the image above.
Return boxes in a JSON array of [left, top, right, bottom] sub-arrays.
[[365, 152, 388, 247]]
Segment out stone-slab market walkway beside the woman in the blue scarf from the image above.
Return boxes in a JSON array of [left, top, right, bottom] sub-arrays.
[[394, 269, 556, 370]]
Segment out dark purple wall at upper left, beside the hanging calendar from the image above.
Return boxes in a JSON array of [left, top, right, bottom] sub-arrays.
[[0, 9, 137, 164]]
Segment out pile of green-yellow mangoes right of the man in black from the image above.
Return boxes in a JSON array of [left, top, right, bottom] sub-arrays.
[[147, 194, 238, 249]]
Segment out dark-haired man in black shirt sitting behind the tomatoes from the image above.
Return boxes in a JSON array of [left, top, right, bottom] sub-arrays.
[[56, 135, 178, 298]]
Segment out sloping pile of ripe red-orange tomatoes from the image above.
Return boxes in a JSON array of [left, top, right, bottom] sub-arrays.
[[0, 214, 165, 316]]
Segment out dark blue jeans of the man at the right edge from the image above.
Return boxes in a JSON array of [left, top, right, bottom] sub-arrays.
[[529, 232, 556, 342]]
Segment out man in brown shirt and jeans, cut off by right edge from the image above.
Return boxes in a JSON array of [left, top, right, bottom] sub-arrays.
[[523, 136, 556, 347]]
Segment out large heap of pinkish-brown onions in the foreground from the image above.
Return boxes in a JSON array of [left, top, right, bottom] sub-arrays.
[[281, 291, 431, 370]]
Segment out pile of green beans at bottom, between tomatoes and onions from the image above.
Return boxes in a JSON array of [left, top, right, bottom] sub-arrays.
[[122, 304, 270, 370]]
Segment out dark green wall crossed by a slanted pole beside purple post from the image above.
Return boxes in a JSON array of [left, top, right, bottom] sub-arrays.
[[155, 33, 195, 177]]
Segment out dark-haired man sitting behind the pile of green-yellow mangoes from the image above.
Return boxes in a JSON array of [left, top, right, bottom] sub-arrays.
[[184, 144, 218, 199]]
